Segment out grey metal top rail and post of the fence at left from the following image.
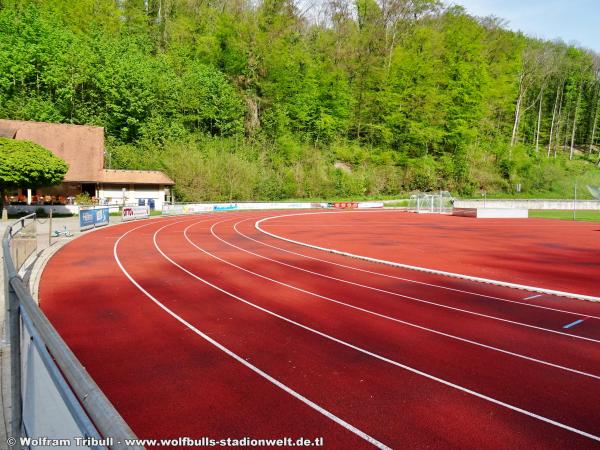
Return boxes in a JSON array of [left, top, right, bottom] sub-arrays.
[[2, 213, 144, 450]]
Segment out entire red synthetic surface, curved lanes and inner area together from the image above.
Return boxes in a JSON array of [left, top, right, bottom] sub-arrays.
[[40, 212, 600, 449]]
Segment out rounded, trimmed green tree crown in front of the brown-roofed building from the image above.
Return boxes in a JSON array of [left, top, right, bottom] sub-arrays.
[[0, 138, 69, 213]]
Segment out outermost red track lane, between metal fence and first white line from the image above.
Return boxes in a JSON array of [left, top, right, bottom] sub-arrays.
[[40, 216, 370, 448]]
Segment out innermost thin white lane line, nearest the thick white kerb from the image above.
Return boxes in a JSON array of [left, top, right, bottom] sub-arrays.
[[233, 218, 600, 319]]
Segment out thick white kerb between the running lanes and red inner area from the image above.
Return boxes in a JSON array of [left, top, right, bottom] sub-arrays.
[[254, 211, 600, 302]]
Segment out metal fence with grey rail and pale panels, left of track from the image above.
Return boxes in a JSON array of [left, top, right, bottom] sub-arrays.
[[2, 214, 143, 449]]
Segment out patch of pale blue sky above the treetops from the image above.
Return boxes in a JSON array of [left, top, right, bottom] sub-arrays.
[[454, 0, 600, 53]]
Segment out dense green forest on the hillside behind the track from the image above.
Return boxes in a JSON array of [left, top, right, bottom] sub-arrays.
[[0, 0, 600, 201]]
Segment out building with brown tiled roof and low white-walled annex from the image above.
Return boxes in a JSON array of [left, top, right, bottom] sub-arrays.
[[0, 119, 174, 210]]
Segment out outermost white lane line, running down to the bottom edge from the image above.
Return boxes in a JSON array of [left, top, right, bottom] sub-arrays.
[[113, 220, 391, 450]]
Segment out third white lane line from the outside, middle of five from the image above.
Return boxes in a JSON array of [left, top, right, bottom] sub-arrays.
[[183, 219, 600, 380]]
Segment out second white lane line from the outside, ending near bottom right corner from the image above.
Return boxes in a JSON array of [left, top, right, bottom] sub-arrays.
[[154, 220, 600, 442]]
